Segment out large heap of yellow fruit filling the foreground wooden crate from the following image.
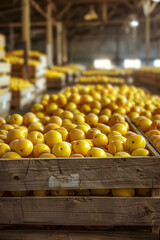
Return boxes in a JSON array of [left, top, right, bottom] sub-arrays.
[[0, 84, 160, 196]]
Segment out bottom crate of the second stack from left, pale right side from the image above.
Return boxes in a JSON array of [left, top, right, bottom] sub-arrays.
[[11, 86, 35, 111]]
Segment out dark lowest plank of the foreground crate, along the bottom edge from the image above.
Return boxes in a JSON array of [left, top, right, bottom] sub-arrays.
[[0, 230, 158, 240]]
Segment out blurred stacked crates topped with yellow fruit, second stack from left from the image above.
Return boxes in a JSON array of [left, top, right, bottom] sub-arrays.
[[3, 50, 47, 111]]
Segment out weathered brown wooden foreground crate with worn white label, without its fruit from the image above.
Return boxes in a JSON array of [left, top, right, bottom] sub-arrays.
[[0, 120, 160, 240]]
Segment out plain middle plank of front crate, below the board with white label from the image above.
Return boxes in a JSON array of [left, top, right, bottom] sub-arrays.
[[0, 197, 160, 227]]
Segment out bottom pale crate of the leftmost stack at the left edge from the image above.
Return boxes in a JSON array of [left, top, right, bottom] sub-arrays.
[[0, 92, 11, 117]]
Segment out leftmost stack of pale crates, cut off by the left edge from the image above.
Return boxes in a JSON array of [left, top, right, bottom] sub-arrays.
[[0, 34, 11, 117]]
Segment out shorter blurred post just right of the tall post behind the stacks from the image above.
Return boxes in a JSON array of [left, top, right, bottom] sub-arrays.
[[57, 22, 62, 65]]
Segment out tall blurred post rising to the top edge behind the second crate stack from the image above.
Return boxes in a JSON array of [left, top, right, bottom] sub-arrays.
[[47, 1, 53, 68]]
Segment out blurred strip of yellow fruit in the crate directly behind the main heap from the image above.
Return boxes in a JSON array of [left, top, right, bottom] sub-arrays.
[[78, 75, 124, 83]]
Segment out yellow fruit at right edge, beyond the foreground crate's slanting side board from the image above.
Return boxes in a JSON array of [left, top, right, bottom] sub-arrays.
[[134, 108, 160, 150]]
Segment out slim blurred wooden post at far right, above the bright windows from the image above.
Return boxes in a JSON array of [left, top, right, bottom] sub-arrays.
[[145, 13, 150, 65]]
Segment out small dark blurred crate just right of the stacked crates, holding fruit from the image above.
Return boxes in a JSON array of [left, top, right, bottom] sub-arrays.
[[47, 77, 66, 89]]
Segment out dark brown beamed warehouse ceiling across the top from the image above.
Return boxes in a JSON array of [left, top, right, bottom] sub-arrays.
[[0, 0, 160, 39]]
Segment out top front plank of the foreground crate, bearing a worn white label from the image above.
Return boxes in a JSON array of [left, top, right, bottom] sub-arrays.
[[0, 157, 160, 191]]
